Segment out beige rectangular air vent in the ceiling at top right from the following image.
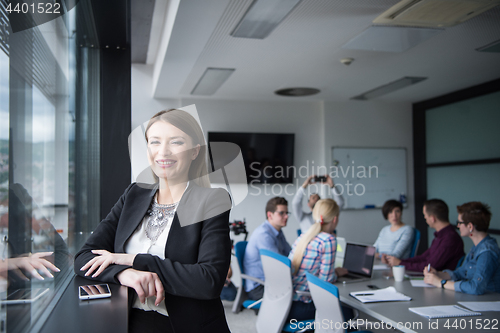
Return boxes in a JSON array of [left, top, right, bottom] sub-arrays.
[[373, 0, 500, 28]]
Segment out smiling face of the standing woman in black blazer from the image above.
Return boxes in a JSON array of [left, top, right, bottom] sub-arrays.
[[147, 120, 200, 183]]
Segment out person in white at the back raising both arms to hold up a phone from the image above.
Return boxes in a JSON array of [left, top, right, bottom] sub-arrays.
[[292, 175, 344, 233]]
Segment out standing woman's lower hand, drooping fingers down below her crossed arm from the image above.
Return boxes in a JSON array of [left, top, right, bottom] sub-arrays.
[[116, 268, 165, 306]]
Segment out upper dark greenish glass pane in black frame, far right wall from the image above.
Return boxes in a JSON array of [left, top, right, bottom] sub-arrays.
[[425, 92, 500, 163]]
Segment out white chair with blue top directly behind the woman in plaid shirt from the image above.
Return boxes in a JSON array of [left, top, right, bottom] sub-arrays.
[[257, 250, 314, 333]]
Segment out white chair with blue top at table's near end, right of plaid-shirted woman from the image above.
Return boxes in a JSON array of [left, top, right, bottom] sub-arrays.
[[306, 272, 370, 333]]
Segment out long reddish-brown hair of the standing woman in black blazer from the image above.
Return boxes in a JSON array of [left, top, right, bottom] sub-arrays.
[[144, 109, 210, 187]]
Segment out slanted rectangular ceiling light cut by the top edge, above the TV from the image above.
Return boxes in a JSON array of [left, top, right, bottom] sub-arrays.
[[231, 0, 300, 39]]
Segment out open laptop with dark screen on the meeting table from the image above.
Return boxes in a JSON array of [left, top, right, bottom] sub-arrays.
[[337, 243, 376, 283]]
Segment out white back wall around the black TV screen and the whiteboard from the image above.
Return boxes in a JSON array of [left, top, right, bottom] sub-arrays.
[[132, 65, 414, 243]]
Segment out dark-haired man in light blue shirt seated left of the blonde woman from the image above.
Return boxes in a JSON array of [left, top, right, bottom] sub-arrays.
[[243, 197, 291, 300]]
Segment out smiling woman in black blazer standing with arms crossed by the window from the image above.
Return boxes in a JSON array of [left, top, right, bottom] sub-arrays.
[[75, 110, 231, 333]]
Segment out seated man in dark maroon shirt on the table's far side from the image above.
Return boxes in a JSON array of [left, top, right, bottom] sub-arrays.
[[382, 199, 464, 272]]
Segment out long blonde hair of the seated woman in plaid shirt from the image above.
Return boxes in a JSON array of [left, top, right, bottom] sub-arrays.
[[292, 199, 340, 275]]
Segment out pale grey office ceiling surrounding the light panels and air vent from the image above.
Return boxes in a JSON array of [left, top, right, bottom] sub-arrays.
[[132, 0, 500, 103]]
